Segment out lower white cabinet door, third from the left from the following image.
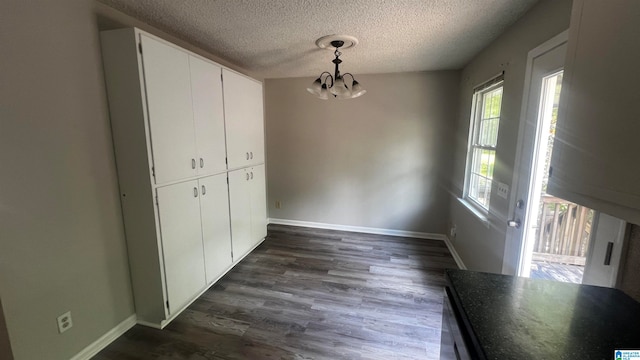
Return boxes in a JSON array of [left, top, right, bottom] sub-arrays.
[[229, 169, 254, 261]]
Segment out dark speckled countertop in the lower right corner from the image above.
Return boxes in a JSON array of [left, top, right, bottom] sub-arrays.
[[446, 270, 640, 360]]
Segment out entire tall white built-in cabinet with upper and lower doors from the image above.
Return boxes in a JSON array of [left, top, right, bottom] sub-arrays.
[[101, 29, 266, 328]]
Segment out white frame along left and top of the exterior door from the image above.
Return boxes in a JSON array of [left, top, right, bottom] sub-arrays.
[[502, 30, 569, 275]]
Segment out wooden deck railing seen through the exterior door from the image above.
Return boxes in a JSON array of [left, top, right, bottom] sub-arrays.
[[533, 195, 593, 265]]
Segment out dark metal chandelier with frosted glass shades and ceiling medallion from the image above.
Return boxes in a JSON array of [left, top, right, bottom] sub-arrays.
[[307, 35, 367, 100]]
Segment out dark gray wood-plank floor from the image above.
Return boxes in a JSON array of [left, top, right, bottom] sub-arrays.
[[94, 225, 456, 360]]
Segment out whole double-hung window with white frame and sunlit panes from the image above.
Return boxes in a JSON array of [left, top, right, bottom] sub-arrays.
[[465, 76, 503, 211]]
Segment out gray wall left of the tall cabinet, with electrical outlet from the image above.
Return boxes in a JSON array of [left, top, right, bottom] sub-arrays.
[[0, 0, 134, 359]]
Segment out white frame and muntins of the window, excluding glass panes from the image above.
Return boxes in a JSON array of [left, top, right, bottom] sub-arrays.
[[463, 74, 504, 212]]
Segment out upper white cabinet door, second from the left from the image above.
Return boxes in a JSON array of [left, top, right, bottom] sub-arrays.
[[189, 56, 227, 175]]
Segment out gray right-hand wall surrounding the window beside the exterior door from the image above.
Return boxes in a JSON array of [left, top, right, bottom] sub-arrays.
[[450, 0, 571, 273]]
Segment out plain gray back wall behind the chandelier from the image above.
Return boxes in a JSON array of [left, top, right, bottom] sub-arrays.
[[265, 71, 459, 233]]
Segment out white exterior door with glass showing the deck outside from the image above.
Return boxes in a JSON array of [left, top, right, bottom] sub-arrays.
[[503, 33, 626, 287]]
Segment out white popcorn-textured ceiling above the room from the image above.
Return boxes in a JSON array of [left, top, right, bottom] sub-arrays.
[[100, 0, 537, 78]]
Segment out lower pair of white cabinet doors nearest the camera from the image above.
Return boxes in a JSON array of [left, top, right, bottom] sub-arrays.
[[157, 174, 232, 315]]
